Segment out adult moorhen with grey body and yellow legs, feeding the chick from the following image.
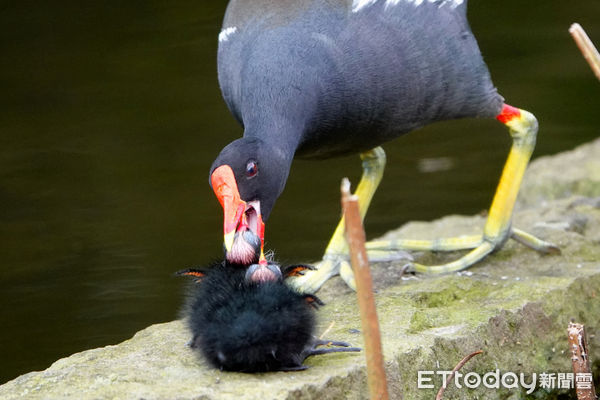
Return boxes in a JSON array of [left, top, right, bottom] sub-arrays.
[[210, 0, 558, 293]]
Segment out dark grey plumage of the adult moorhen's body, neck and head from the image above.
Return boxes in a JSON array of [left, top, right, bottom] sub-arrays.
[[211, 0, 503, 220]]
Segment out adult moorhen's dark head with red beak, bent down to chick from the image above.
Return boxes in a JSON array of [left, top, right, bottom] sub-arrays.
[[210, 138, 290, 281]]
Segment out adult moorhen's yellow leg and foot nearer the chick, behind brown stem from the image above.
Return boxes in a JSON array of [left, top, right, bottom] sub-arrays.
[[289, 147, 392, 293]]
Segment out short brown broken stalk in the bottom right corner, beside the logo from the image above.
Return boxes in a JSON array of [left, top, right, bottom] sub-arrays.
[[567, 322, 596, 400]]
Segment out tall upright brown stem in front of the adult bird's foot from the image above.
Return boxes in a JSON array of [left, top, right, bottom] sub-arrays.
[[341, 178, 389, 400]]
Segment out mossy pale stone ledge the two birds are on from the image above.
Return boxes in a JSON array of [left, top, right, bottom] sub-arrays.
[[0, 140, 600, 400]]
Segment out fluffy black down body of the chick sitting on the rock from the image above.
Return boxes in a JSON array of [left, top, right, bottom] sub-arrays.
[[184, 263, 315, 372]]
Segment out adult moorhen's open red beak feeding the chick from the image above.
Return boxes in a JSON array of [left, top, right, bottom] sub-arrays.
[[210, 165, 267, 265]]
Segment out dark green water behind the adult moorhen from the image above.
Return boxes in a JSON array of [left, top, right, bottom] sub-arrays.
[[0, 0, 600, 383]]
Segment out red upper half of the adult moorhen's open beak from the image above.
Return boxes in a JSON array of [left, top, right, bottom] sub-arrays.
[[210, 165, 246, 252]]
